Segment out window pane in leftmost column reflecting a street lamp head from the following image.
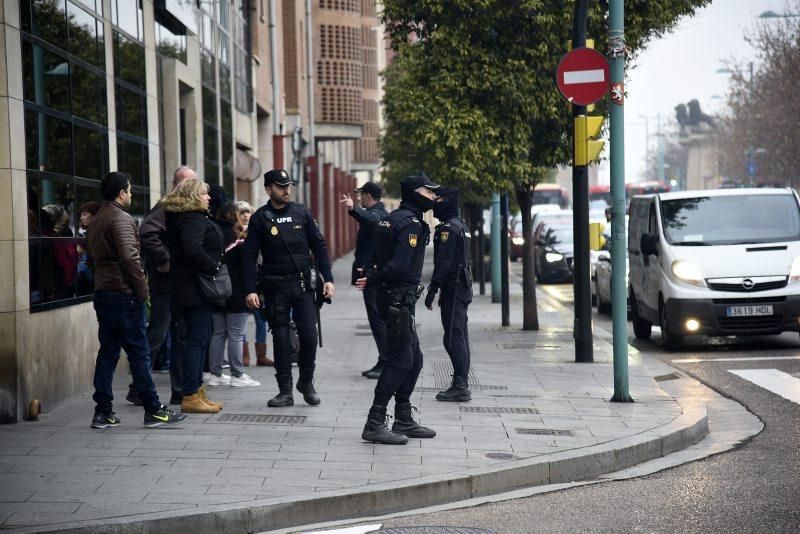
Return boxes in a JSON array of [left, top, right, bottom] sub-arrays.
[[22, 41, 70, 113]]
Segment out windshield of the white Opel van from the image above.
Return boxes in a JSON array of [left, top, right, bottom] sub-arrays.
[[661, 195, 800, 246]]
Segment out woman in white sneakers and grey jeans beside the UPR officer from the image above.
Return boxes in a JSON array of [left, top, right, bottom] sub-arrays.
[[208, 202, 261, 387]]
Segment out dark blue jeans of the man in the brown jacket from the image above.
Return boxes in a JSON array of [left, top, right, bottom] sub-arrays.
[[92, 291, 161, 414]]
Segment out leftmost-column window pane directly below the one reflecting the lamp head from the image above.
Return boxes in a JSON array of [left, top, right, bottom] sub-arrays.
[[25, 110, 72, 175]]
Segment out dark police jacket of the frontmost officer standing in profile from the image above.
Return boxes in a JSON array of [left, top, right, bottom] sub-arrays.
[[367, 202, 430, 286]]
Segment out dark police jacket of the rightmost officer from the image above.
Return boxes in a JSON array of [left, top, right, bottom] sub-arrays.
[[428, 217, 472, 297]]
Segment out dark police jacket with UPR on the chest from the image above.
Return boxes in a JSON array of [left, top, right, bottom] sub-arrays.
[[242, 202, 333, 294]]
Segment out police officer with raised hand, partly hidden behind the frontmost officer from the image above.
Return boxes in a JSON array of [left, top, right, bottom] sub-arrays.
[[339, 182, 389, 378]]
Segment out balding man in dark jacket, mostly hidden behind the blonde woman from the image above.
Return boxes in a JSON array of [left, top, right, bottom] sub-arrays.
[[126, 166, 197, 405]]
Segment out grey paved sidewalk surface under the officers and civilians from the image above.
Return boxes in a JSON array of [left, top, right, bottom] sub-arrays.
[[0, 253, 682, 528]]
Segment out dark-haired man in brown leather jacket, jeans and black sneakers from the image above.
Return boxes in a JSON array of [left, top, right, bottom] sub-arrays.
[[86, 172, 186, 434]]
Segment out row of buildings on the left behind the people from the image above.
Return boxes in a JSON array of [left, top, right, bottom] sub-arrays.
[[0, 0, 382, 428]]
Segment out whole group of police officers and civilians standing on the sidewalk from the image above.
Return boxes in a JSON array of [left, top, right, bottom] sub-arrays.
[[87, 167, 472, 444]]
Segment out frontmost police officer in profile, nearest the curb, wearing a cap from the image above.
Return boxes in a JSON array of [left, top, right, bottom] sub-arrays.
[[356, 174, 439, 445]]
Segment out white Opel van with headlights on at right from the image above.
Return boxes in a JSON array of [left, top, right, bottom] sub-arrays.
[[628, 189, 800, 349]]
